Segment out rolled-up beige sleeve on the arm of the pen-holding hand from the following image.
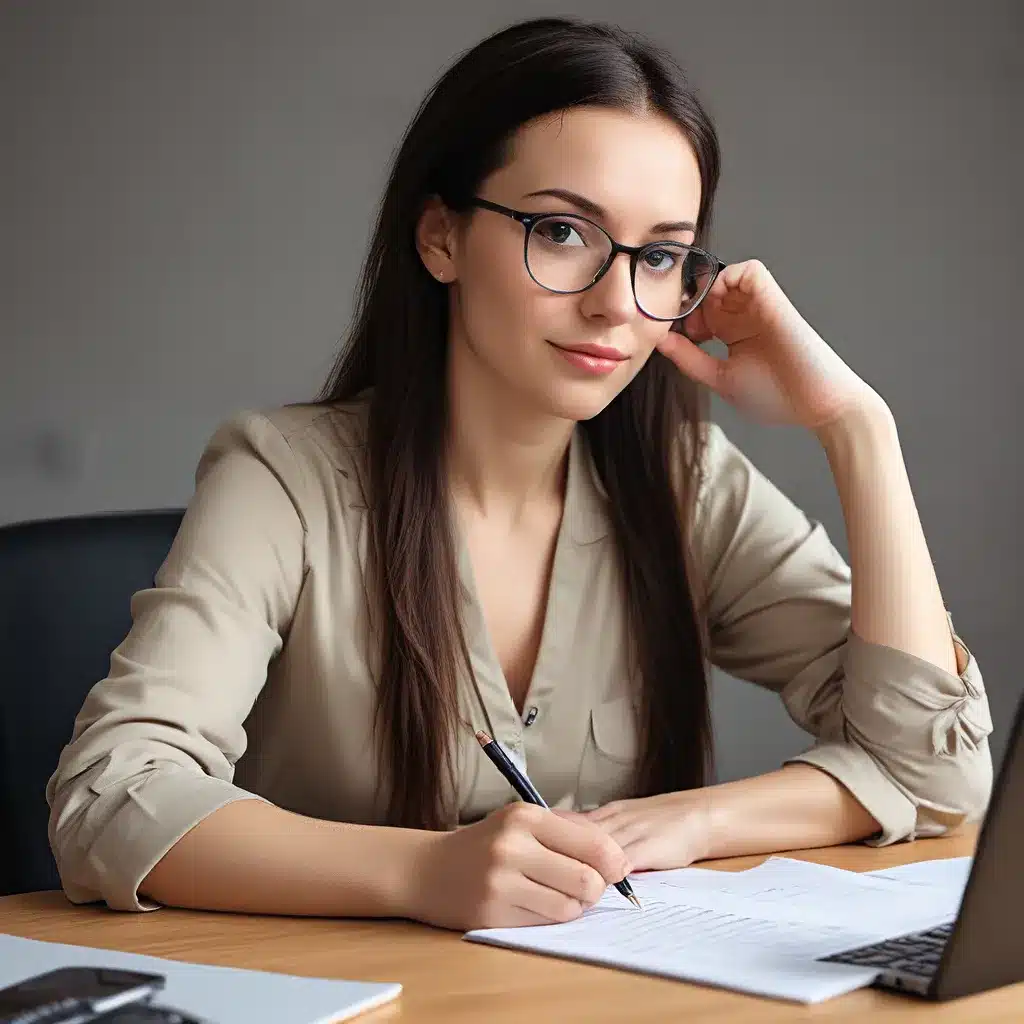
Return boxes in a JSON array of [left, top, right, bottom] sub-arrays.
[[46, 413, 305, 910]]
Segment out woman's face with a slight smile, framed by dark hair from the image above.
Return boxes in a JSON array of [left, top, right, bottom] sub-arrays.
[[421, 101, 700, 421]]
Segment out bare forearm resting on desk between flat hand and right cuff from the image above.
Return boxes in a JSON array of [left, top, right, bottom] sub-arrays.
[[693, 764, 880, 859]]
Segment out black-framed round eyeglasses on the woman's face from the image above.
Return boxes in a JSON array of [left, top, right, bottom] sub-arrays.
[[469, 197, 726, 321]]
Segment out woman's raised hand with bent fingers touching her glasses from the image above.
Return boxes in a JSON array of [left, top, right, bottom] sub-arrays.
[[657, 260, 882, 430]]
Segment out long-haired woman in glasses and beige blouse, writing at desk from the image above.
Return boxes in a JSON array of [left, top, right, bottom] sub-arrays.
[[48, 19, 991, 929]]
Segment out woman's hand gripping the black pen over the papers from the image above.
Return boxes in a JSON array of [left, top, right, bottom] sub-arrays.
[[411, 803, 631, 931]]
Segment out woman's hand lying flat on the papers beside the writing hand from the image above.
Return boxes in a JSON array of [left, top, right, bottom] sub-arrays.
[[555, 790, 711, 871]]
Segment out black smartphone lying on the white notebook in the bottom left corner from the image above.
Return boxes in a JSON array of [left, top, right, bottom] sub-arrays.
[[0, 967, 165, 1024]]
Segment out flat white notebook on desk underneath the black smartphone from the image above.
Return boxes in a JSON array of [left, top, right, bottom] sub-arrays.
[[0, 935, 401, 1024]]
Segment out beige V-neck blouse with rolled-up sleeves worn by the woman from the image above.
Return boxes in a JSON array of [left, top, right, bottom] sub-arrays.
[[47, 400, 992, 910]]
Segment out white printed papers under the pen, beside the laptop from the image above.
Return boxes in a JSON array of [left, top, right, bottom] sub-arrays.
[[465, 857, 970, 1002]]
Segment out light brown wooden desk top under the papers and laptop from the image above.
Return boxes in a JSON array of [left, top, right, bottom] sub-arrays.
[[0, 829, 1024, 1024]]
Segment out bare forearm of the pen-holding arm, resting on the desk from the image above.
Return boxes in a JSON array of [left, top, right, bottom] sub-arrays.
[[139, 800, 440, 918]]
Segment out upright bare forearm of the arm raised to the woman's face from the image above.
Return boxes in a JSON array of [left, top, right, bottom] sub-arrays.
[[818, 401, 958, 673]]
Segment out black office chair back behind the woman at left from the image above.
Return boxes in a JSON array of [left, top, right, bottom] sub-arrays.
[[0, 509, 182, 895]]
